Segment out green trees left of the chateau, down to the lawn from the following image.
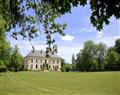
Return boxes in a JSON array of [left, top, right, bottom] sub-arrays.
[[0, 31, 23, 72]]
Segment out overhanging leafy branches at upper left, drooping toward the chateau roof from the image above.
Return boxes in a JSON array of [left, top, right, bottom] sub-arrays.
[[0, 0, 66, 57]]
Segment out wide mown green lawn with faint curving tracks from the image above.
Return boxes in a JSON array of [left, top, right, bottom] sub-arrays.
[[0, 72, 120, 95]]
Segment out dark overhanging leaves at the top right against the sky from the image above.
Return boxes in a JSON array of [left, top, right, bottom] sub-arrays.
[[43, 0, 120, 30]]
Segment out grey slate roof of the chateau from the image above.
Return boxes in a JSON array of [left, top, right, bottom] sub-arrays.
[[26, 50, 61, 58]]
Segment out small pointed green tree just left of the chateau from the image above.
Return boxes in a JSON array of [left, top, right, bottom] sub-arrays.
[[9, 46, 23, 71]]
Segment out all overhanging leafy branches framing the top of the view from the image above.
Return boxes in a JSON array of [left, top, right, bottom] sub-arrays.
[[0, 0, 120, 54]]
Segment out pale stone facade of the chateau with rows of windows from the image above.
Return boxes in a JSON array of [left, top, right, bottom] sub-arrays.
[[24, 57, 61, 71]]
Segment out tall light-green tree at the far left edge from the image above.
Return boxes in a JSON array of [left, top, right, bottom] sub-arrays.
[[0, 16, 11, 71]]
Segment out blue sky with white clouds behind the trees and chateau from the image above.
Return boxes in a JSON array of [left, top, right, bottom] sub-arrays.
[[8, 5, 120, 63]]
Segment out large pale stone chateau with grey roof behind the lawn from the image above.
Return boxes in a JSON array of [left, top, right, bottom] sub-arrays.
[[24, 48, 61, 71]]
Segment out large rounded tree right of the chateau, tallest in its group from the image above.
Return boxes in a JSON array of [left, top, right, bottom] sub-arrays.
[[76, 41, 107, 71]]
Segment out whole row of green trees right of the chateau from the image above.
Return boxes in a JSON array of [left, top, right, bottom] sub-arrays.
[[72, 39, 120, 71]]
